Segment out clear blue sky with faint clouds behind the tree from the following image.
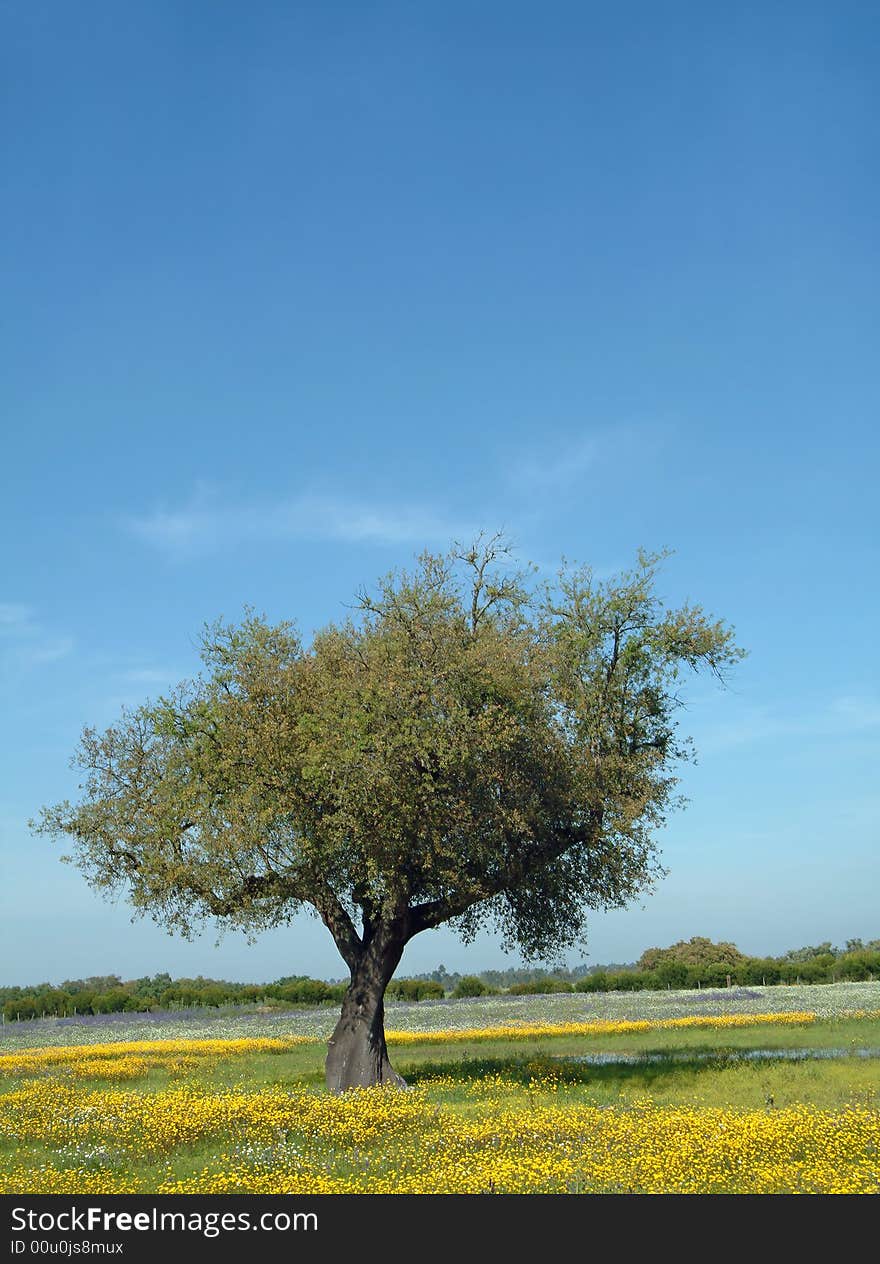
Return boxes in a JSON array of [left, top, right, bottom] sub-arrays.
[[0, 0, 880, 983]]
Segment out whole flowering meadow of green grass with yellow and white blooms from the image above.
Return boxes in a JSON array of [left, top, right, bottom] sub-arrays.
[[0, 988, 880, 1193]]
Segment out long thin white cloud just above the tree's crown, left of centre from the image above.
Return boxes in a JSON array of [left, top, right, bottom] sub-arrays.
[[126, 488, 474, 557]]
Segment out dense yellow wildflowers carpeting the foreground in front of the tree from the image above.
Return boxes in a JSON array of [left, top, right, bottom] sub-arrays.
[[0, 1056, 880, 1193]]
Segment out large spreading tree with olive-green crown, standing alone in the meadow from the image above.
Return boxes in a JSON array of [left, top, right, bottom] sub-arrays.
[[33, 536, 743, 1091]]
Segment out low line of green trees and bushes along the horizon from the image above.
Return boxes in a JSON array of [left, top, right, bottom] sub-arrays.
[[0, 937, 880, 1023]]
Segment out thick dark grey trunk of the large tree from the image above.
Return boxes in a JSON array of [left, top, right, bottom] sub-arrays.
[[325, 940, 406, 1093]]
